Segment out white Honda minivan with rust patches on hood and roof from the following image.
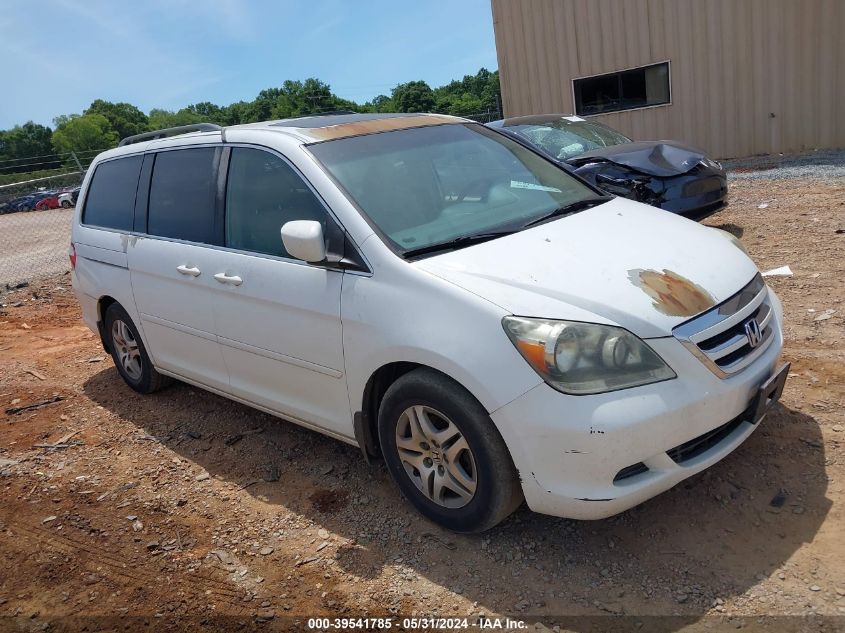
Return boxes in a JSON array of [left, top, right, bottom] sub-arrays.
[[70, 114, 788, 532]]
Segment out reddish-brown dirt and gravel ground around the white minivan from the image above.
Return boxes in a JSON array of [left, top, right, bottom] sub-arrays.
[[0, 174, 845, 631]]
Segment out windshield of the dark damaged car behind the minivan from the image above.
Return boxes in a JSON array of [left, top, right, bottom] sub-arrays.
[[508, 119, 631, 160]]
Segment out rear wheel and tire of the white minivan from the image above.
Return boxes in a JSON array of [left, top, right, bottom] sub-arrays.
[[104, 303, 172, 394]]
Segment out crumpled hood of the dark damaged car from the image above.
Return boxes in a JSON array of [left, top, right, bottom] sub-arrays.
[[566, 141, 704, 178]]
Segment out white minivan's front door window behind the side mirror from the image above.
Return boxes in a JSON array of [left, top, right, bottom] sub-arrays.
[[226, 147, 328, 257]]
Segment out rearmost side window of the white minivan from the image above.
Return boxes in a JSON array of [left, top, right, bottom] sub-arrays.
[[82, 156, 143, 231]]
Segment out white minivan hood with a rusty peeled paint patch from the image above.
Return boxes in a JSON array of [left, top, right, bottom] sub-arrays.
[[414, 198, 757, 338]]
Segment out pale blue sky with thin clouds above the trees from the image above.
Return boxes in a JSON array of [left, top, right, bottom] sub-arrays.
[[0, 0, 497, 129]]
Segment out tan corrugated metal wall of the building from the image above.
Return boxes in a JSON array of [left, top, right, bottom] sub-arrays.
[[492, 0, 845, 158]]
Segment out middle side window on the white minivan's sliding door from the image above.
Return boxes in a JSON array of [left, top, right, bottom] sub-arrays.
[[147, 147, 217, 244]]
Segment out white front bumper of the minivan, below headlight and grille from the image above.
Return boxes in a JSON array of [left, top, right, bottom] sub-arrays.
[[491, 292, 783, 519]]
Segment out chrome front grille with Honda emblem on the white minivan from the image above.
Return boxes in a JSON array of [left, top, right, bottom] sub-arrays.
[[672, 273, 775, 378]]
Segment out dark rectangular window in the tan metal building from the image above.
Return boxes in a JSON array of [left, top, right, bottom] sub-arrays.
[[572, 62, 671, 115]]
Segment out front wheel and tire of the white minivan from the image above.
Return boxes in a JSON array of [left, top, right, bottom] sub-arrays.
[[378, 368, 522, 532]]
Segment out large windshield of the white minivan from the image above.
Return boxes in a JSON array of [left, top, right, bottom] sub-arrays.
[[309, 124, 596, 253]]
